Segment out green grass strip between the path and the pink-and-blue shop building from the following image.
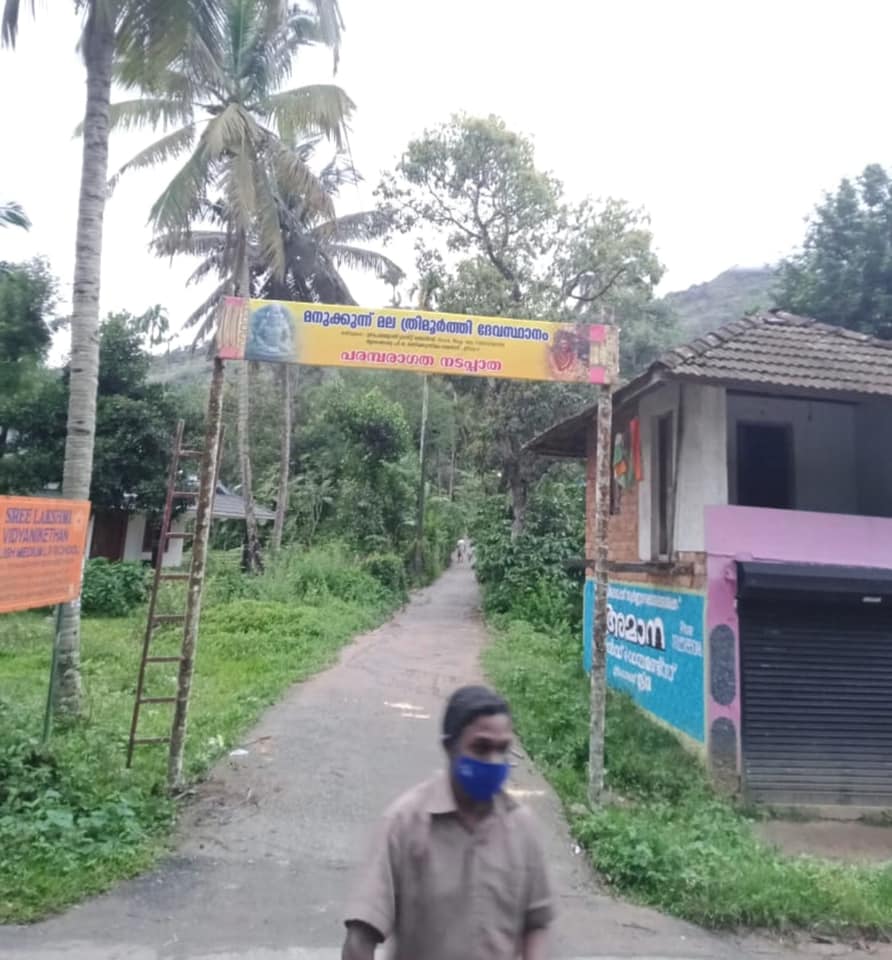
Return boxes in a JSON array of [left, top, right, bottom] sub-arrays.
[[484, 619, 892, 936]]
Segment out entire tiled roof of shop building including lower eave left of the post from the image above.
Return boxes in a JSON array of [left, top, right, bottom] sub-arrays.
[[527, 311, 892, 458]]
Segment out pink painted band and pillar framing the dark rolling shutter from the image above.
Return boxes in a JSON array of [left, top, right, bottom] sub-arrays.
[[706, 506, 892, 773]]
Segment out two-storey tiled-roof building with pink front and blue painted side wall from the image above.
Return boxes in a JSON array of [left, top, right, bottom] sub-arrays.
[[529, 312, 892, 807]]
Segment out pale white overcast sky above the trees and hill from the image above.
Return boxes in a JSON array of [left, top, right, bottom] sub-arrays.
[[0, 0, 892, 352]]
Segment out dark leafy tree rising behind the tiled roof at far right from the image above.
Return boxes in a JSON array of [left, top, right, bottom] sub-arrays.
[[777, 164, 892, 336]]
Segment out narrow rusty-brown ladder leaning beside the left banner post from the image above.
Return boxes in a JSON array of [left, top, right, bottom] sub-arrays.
[[127, 420, 222, 767]]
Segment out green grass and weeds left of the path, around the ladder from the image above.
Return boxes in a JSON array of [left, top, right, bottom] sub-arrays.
[[0, 546, 402, 923]]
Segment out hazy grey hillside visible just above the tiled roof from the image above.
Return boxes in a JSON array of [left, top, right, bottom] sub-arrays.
[[664, 266, 776, 342]]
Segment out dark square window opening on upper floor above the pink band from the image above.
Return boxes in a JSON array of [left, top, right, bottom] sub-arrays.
[[737, 423, 794, 510]]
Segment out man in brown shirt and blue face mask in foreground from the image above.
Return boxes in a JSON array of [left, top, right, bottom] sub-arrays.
[[342, 687, 553, 960]]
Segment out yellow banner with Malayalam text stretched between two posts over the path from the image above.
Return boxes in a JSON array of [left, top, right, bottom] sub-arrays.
[[217, 297, 618, 384]]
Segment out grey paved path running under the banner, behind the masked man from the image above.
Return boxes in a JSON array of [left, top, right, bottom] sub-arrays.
[[0, 568, 884, 960]]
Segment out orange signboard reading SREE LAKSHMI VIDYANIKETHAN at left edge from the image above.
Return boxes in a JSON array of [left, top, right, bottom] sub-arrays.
[[0, 497, 90, 613]]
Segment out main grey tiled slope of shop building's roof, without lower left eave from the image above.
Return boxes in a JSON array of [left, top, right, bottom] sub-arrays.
[[651, 312, 892, 397]]
